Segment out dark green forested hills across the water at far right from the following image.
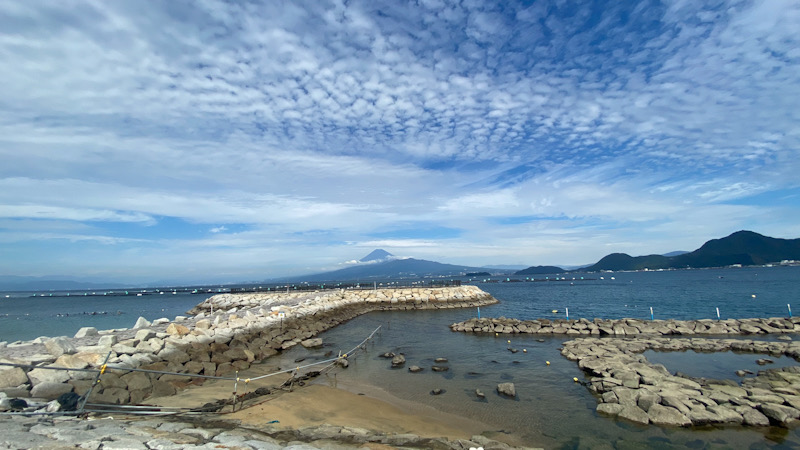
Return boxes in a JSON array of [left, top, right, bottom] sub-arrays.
[[583, 231, 800, 272]]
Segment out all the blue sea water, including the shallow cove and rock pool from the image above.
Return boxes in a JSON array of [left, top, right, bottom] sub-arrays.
[[0, 266, 800, 449]]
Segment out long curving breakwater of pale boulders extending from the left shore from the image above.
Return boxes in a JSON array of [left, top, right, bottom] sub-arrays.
[[0, 286, 497, 404]]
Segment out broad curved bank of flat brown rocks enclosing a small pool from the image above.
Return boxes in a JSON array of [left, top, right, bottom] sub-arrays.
[[561, 338, 800, 426]]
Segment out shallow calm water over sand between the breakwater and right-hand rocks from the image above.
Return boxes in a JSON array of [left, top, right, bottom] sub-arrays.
[[310, 310, 800, 448]]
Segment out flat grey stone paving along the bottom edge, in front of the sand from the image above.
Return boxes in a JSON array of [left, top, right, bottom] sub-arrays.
[[0, 416, 540, 450]]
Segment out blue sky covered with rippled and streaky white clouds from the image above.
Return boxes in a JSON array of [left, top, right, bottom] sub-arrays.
[[0, 0, 800, 283]]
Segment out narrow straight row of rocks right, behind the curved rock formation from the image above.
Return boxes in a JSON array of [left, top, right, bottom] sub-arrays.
[[450, 317, 800, 336]]
